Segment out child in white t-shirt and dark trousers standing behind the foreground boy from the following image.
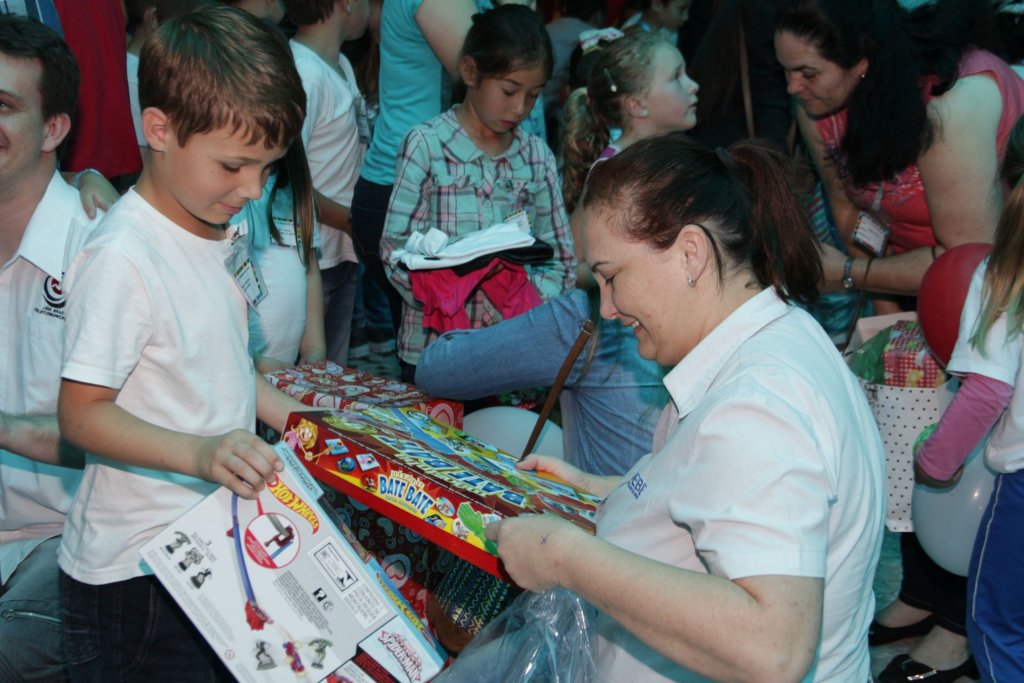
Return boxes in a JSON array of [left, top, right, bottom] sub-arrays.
[[285, 0, 370, 365]]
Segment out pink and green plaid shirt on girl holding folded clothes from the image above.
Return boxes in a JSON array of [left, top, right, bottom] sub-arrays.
[[380, 108, 575, 365]]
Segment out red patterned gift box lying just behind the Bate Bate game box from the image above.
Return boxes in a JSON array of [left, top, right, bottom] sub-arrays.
[[266, 360, 463, 427]]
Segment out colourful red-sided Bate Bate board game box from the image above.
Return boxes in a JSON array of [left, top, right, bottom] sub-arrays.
[[283, 407, 600, 579]]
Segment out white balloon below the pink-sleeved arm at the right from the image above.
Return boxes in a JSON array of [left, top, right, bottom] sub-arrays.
[[911, 440, 995, 577]]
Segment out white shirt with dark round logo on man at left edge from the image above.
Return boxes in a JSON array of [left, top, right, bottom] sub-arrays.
[[0, 173, 99, 584]]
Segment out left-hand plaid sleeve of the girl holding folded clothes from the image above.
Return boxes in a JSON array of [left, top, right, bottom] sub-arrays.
[[381, 128, 439, 308]]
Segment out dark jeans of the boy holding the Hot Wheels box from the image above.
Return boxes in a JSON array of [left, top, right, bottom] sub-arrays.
[[60, 571, 234, 683]]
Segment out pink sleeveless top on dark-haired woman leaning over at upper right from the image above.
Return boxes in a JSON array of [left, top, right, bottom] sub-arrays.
[[814, 49, 1024, 253]]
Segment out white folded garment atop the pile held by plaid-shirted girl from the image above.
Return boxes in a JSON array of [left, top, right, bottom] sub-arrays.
[[390, 222, 536, 270]]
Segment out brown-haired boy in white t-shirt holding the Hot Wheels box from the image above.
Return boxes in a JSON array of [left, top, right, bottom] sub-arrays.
[[57, 5, 305, 683]]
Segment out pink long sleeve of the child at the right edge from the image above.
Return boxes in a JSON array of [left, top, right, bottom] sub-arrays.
[[916, 373, 1014, 481]]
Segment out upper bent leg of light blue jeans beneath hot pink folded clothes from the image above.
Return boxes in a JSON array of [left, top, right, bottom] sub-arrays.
[[416, 290, 590, 400]]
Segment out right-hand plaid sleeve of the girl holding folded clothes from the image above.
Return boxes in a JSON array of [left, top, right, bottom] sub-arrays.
[[528, 148, 577, 300]]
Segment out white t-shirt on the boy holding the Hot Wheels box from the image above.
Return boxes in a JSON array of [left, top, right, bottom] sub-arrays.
[[59, 189, 256, 585]]
